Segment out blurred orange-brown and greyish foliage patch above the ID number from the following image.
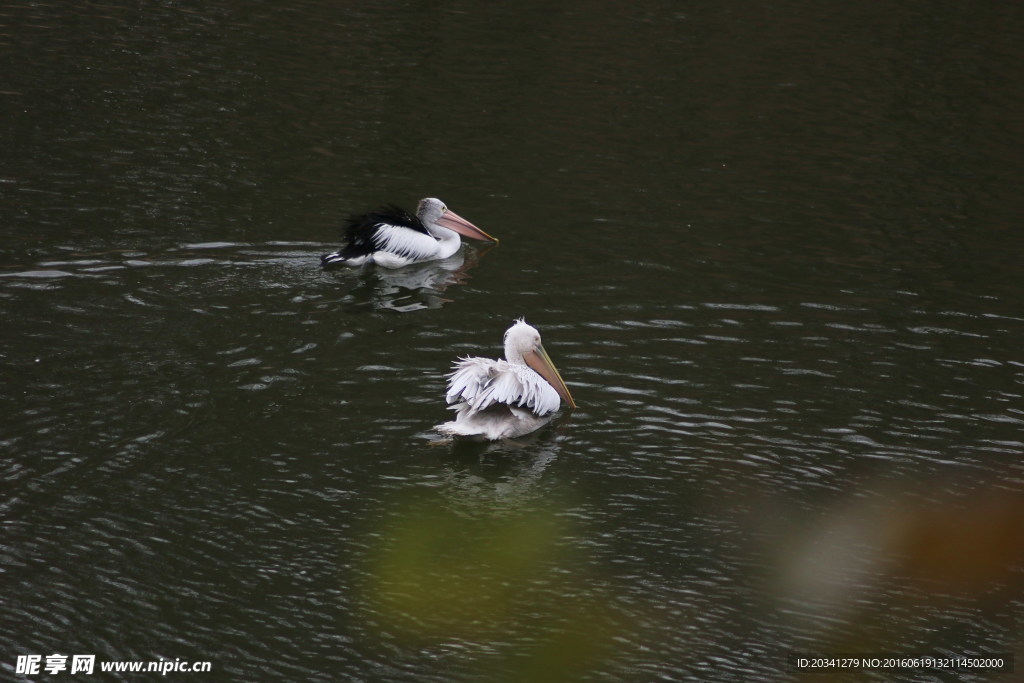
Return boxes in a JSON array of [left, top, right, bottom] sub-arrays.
[[766, 479, 1024, 680]]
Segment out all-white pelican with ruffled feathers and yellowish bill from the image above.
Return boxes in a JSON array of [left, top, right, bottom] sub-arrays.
[[434, 318, 575, 440]]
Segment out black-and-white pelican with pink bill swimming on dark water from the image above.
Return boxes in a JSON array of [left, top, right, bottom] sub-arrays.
[[321, 197, 498, 268]]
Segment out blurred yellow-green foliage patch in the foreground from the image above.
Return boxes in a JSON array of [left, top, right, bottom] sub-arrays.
[[365, 493, 622, 681]]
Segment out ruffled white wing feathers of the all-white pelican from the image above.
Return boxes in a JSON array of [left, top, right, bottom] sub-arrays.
[[445, 358, 559, 415]]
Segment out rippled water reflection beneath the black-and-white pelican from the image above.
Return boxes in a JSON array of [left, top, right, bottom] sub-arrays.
[[333, 245, 493, 313]]
